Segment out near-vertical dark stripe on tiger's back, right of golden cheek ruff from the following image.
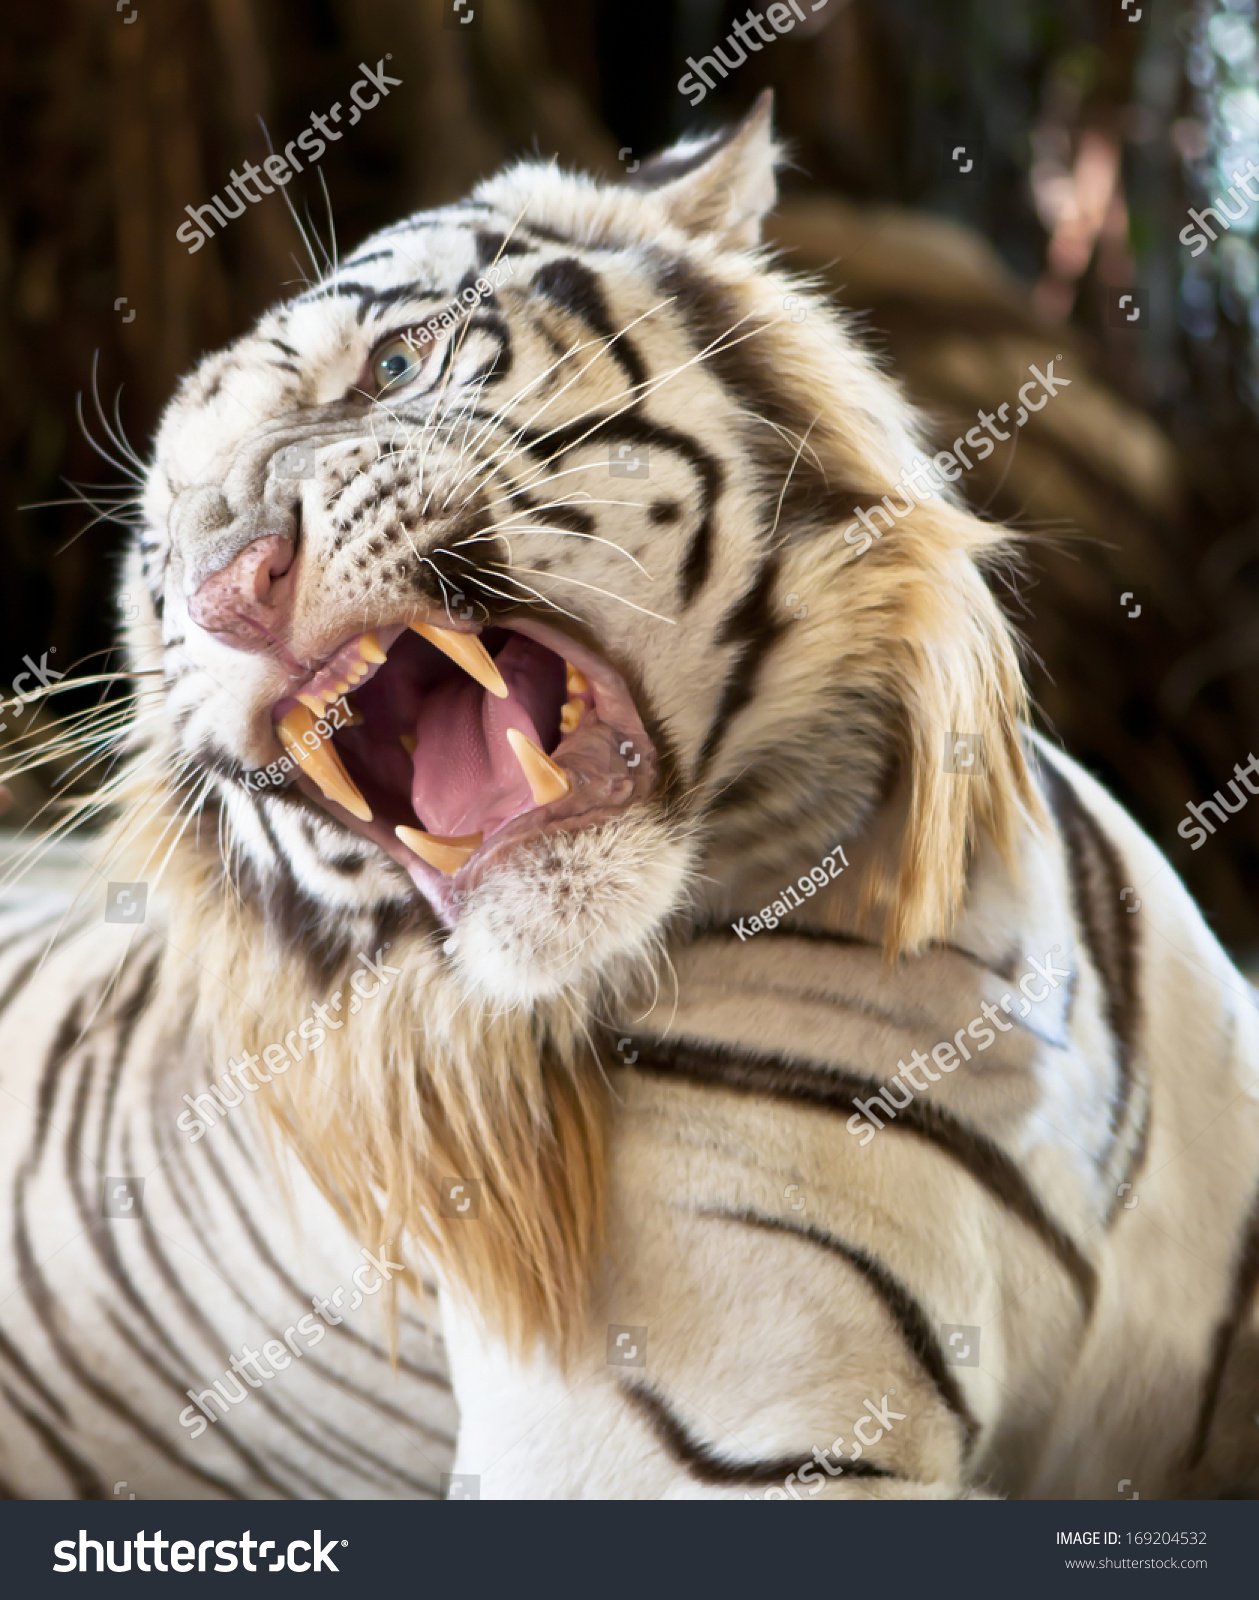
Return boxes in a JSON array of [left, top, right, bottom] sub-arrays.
[[1035, 760, 1141, 1221]]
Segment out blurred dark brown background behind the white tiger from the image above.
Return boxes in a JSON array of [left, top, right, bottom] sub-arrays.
[[0, 0, 1259, 954]]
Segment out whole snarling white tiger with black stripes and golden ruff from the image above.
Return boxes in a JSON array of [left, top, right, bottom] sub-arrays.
[[0, 101, 1259, 1499]]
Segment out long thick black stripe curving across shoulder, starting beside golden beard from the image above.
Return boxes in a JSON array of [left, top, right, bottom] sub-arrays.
[[632, 1038, 1097, 1315]]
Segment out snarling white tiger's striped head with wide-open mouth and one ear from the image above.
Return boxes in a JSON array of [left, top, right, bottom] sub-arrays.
[[128, 93, 1030, 1006]]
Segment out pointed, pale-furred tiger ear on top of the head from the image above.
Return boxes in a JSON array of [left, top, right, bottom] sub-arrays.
[[626, 90, 779, 250]]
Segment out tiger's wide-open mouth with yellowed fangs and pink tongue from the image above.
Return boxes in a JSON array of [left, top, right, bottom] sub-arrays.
[[272, 614, 656, 925]]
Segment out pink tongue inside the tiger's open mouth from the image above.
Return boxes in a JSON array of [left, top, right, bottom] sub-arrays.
[[411, 675, 542, 837]]
